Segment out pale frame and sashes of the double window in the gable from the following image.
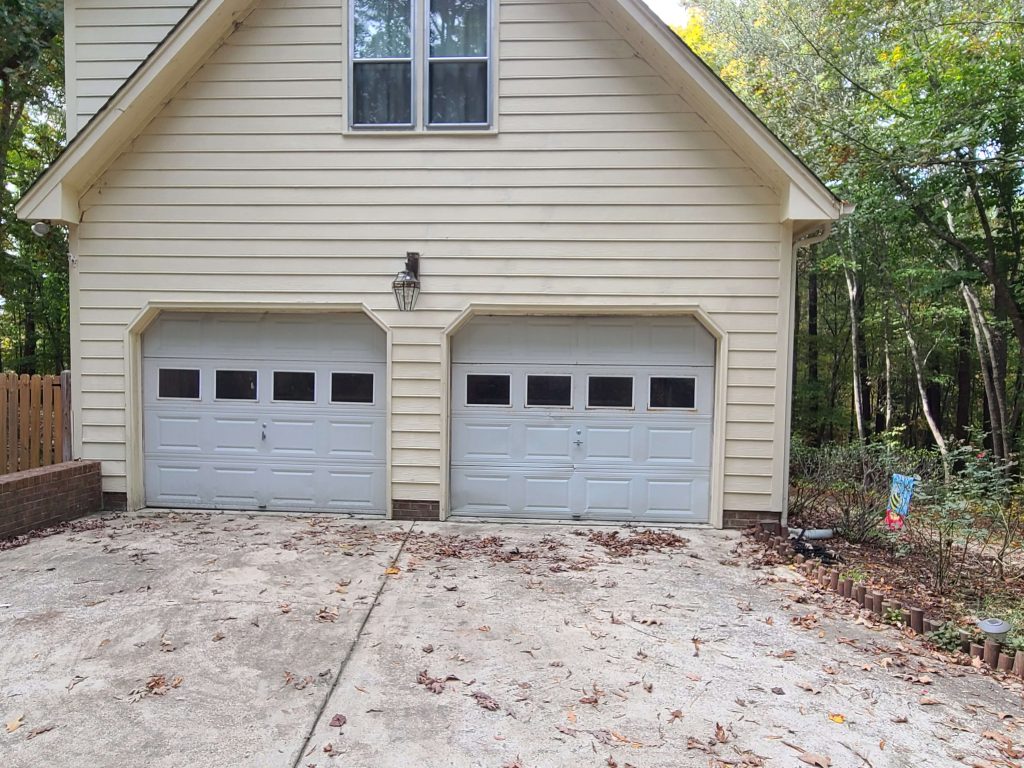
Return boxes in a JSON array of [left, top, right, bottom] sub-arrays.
[[345, 0, 499, 135]]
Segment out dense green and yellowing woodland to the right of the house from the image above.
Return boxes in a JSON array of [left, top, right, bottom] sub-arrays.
[[679, 0, 1024, 461]]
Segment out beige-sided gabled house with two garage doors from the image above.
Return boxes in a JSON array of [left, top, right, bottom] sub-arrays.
[[17, 0, 844, 526]]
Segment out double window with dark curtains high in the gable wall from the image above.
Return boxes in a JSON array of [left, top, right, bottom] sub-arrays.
[[349, 0, 492, 129]]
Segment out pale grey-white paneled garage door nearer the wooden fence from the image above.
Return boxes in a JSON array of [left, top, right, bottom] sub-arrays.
[[142, 313, 386, 514]]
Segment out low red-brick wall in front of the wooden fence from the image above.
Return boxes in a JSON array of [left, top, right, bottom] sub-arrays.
[[0, 462, 101, 539]]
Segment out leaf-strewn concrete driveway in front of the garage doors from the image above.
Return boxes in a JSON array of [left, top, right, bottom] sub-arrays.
[[0, 514, 1024, 768]]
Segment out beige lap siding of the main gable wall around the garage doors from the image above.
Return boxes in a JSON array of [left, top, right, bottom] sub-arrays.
[[76, 0, 788, 518]]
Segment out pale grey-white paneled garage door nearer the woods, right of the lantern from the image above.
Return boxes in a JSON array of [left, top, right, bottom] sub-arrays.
[[451, 317, 715, 522]]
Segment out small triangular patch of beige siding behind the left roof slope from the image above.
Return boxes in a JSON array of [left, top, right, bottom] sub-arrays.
[[65, 0, 193, 139]]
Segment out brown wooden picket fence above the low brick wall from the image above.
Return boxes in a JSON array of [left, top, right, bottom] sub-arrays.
[[0, 371, 71, 475]]
